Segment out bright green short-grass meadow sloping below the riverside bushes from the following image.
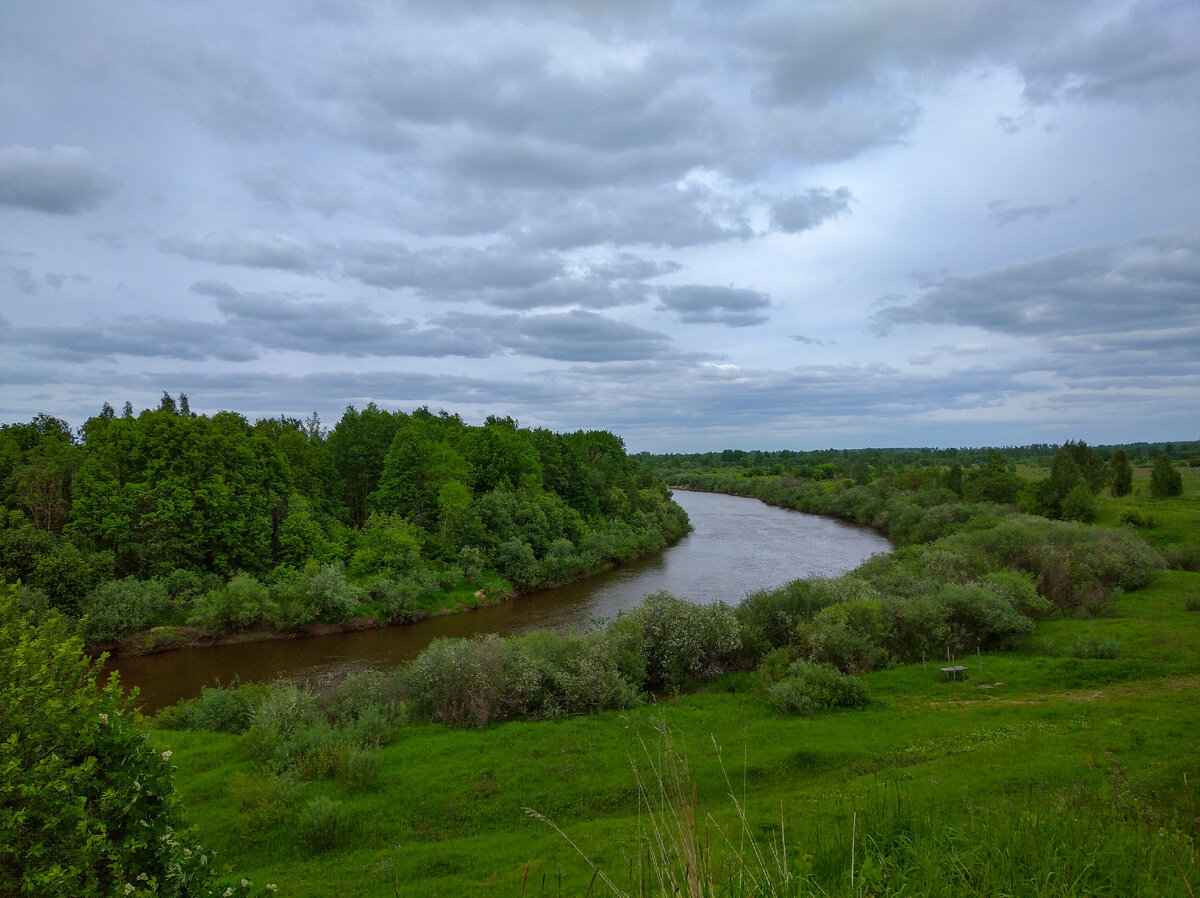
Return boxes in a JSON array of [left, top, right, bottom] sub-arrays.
[[155, 471, 1200, 896]]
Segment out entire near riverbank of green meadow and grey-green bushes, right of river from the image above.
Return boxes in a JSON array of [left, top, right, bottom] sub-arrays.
[[9, 432, 1200, 897]]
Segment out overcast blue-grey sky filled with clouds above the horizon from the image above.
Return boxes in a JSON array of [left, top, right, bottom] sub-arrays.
[[0, 0, 1200, 451]]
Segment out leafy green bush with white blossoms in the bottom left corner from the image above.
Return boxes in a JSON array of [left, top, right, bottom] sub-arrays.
[[0, 587, 214, 898]]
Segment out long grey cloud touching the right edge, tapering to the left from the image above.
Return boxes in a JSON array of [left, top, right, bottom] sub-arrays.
[[874, 228, 1200, 337]]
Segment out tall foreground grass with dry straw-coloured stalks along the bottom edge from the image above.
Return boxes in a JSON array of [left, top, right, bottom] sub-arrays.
[[522, 728, 1200, 898]]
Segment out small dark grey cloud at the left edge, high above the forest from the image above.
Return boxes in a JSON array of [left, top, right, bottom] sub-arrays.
[[0, 146, 118, 215]]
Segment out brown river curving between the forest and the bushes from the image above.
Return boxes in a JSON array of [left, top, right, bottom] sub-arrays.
[[106, 490, 892, 713]]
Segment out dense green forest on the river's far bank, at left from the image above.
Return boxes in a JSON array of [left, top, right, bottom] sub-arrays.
[[0, 394, 689, 642]]
